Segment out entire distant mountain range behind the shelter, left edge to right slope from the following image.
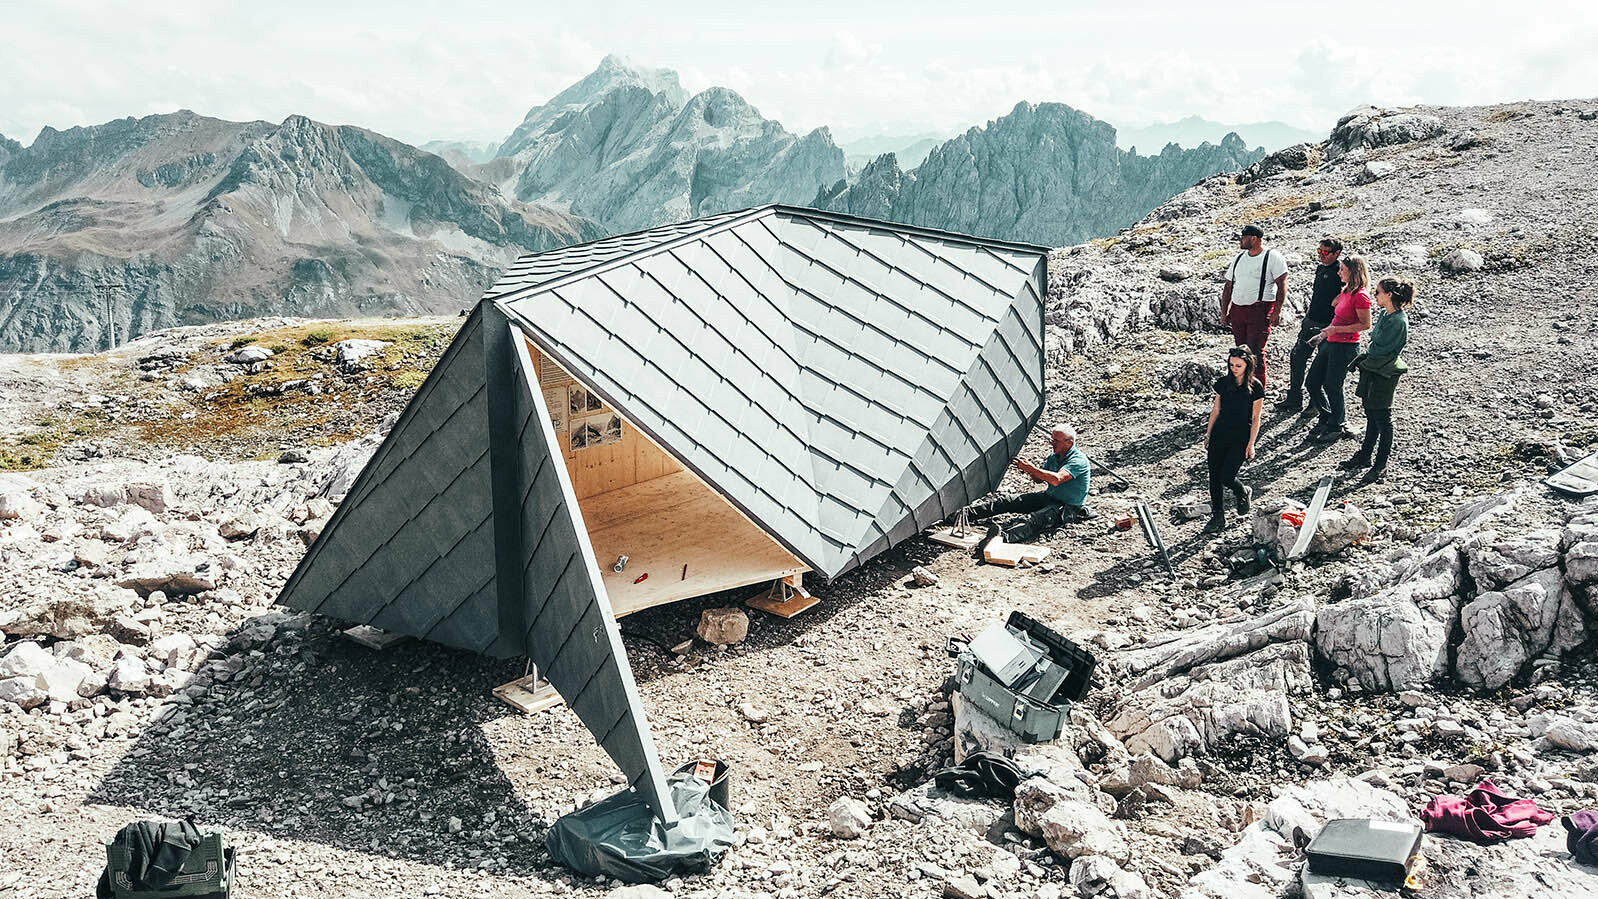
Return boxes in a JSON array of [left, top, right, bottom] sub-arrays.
[[0, 56, 1259, 350]]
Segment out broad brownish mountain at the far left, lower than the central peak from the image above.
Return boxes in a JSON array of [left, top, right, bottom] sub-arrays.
[[0, 110, 601, 350]]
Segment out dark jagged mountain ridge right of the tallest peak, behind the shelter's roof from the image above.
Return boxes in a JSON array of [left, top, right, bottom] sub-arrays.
[[812, 102, 1264, 246]]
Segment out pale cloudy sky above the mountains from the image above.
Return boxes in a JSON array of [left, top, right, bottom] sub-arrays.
[[0, 0, 1598, 144]]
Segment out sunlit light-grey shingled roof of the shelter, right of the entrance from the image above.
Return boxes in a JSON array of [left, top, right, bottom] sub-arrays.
[[484, 206, 1047, 578]]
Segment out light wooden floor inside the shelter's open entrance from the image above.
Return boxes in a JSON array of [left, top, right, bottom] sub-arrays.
[[578, 471, 810, 618]]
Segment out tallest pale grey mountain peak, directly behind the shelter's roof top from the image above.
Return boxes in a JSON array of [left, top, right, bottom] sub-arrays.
[[468, 56, 844, 232]]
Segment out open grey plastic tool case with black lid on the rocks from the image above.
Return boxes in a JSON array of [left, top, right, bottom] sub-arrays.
[[959, 612, 1095, 743]]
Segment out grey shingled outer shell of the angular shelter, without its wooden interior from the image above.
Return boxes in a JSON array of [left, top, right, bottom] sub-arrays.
[[278, 206, 1047, 821]]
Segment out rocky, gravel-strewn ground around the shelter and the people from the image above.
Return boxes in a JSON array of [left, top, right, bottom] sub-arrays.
[[0, 101, 1598, 899]]
